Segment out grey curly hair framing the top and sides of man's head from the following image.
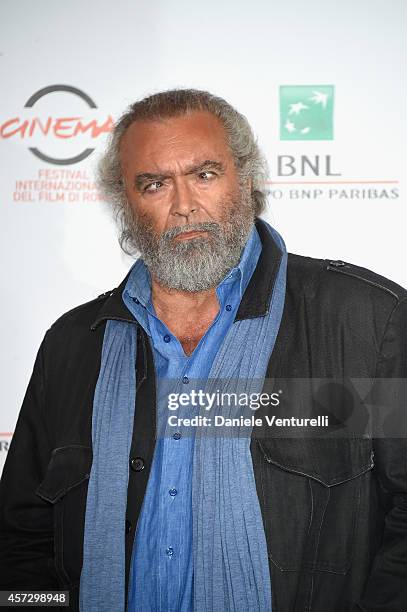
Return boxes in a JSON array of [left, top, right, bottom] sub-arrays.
[[97, 89, 268, 254]]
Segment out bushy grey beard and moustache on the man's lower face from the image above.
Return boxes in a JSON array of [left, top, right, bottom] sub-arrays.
[[130, 194, 254, 293]]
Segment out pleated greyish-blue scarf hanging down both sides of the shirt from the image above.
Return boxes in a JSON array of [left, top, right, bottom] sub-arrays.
[[80, 224, 287, 612]]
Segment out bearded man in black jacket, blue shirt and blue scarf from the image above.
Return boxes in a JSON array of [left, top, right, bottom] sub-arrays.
[[0, 90, 407, 612]]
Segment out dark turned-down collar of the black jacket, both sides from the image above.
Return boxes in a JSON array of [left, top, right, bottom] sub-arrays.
[[91, 219, 282, 330]]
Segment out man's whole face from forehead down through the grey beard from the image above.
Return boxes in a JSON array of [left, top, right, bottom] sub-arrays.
[[120, 112, 253, 291]]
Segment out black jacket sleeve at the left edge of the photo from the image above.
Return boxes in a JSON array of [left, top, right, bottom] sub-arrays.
[[0, 337, 58, 590]]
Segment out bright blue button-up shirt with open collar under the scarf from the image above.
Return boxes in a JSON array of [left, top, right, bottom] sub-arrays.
[[123, 228, 261, 612]]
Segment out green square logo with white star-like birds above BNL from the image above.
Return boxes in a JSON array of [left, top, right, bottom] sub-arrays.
[[280, 85, 334, 140]]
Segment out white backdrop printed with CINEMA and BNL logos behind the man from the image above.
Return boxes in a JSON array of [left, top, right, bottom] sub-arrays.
[[0, 0, 407, 471]]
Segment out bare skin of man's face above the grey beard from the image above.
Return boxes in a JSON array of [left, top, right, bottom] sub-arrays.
[[121, 112, 244, 233]]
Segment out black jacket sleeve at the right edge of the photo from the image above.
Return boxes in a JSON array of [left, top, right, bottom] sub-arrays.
[[359, 298, 407, 612]]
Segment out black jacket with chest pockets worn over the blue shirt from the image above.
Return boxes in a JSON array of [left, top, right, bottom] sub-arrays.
[[0, 221, 407, 612]]
